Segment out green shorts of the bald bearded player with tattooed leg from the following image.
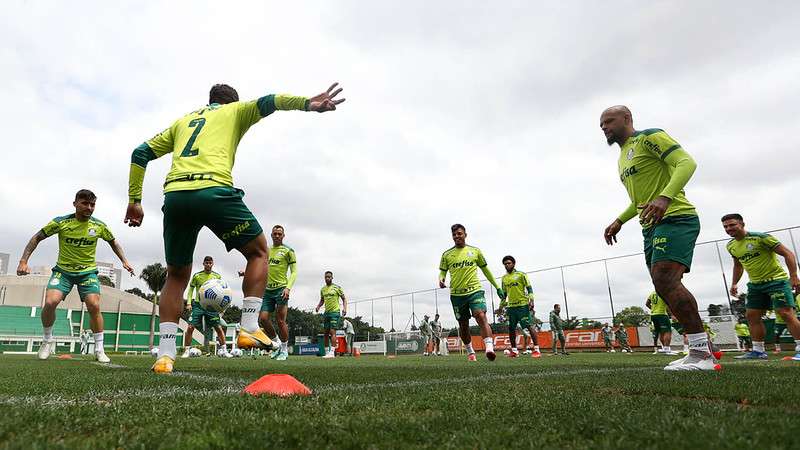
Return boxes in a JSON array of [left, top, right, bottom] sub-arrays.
[[642, 216, 700, 273]]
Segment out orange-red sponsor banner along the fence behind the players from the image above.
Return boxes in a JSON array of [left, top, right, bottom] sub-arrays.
[[447, 327, 639, 352]]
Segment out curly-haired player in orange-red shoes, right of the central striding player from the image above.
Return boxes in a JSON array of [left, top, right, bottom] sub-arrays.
[[500, 255, 542, 358]]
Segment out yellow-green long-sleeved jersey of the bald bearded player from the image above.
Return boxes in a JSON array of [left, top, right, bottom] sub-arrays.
[[618, 128, 697, 226]]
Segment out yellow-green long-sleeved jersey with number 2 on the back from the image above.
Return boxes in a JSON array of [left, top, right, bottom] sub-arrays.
[[128, 94, 308, 202]]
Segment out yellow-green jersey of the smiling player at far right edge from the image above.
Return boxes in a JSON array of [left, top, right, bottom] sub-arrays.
[[725, 231, 789, 283]]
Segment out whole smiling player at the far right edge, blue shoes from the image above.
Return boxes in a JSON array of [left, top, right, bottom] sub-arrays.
[[722, 214, 800, 361]]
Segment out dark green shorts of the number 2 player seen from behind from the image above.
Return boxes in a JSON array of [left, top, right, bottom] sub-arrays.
[[161, 186, 262, 266]]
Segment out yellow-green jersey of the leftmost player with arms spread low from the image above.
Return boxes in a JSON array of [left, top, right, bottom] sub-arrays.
[[42, 214, 114, 274]]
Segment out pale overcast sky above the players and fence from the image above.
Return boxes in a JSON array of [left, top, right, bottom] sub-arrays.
[[0, 1, 800, 329]]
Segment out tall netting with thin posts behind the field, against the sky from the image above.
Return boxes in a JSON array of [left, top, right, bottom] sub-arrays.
[[349, 226, 800, 334]]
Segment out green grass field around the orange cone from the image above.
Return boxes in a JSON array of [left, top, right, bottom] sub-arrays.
[[0, 353, 800, 450]]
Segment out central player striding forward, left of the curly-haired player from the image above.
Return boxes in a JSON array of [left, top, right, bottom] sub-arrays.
[[439, 223, 506, 361]]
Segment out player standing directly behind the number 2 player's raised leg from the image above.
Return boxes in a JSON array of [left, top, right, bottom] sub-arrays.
[[258, 225, 297, 361]]
